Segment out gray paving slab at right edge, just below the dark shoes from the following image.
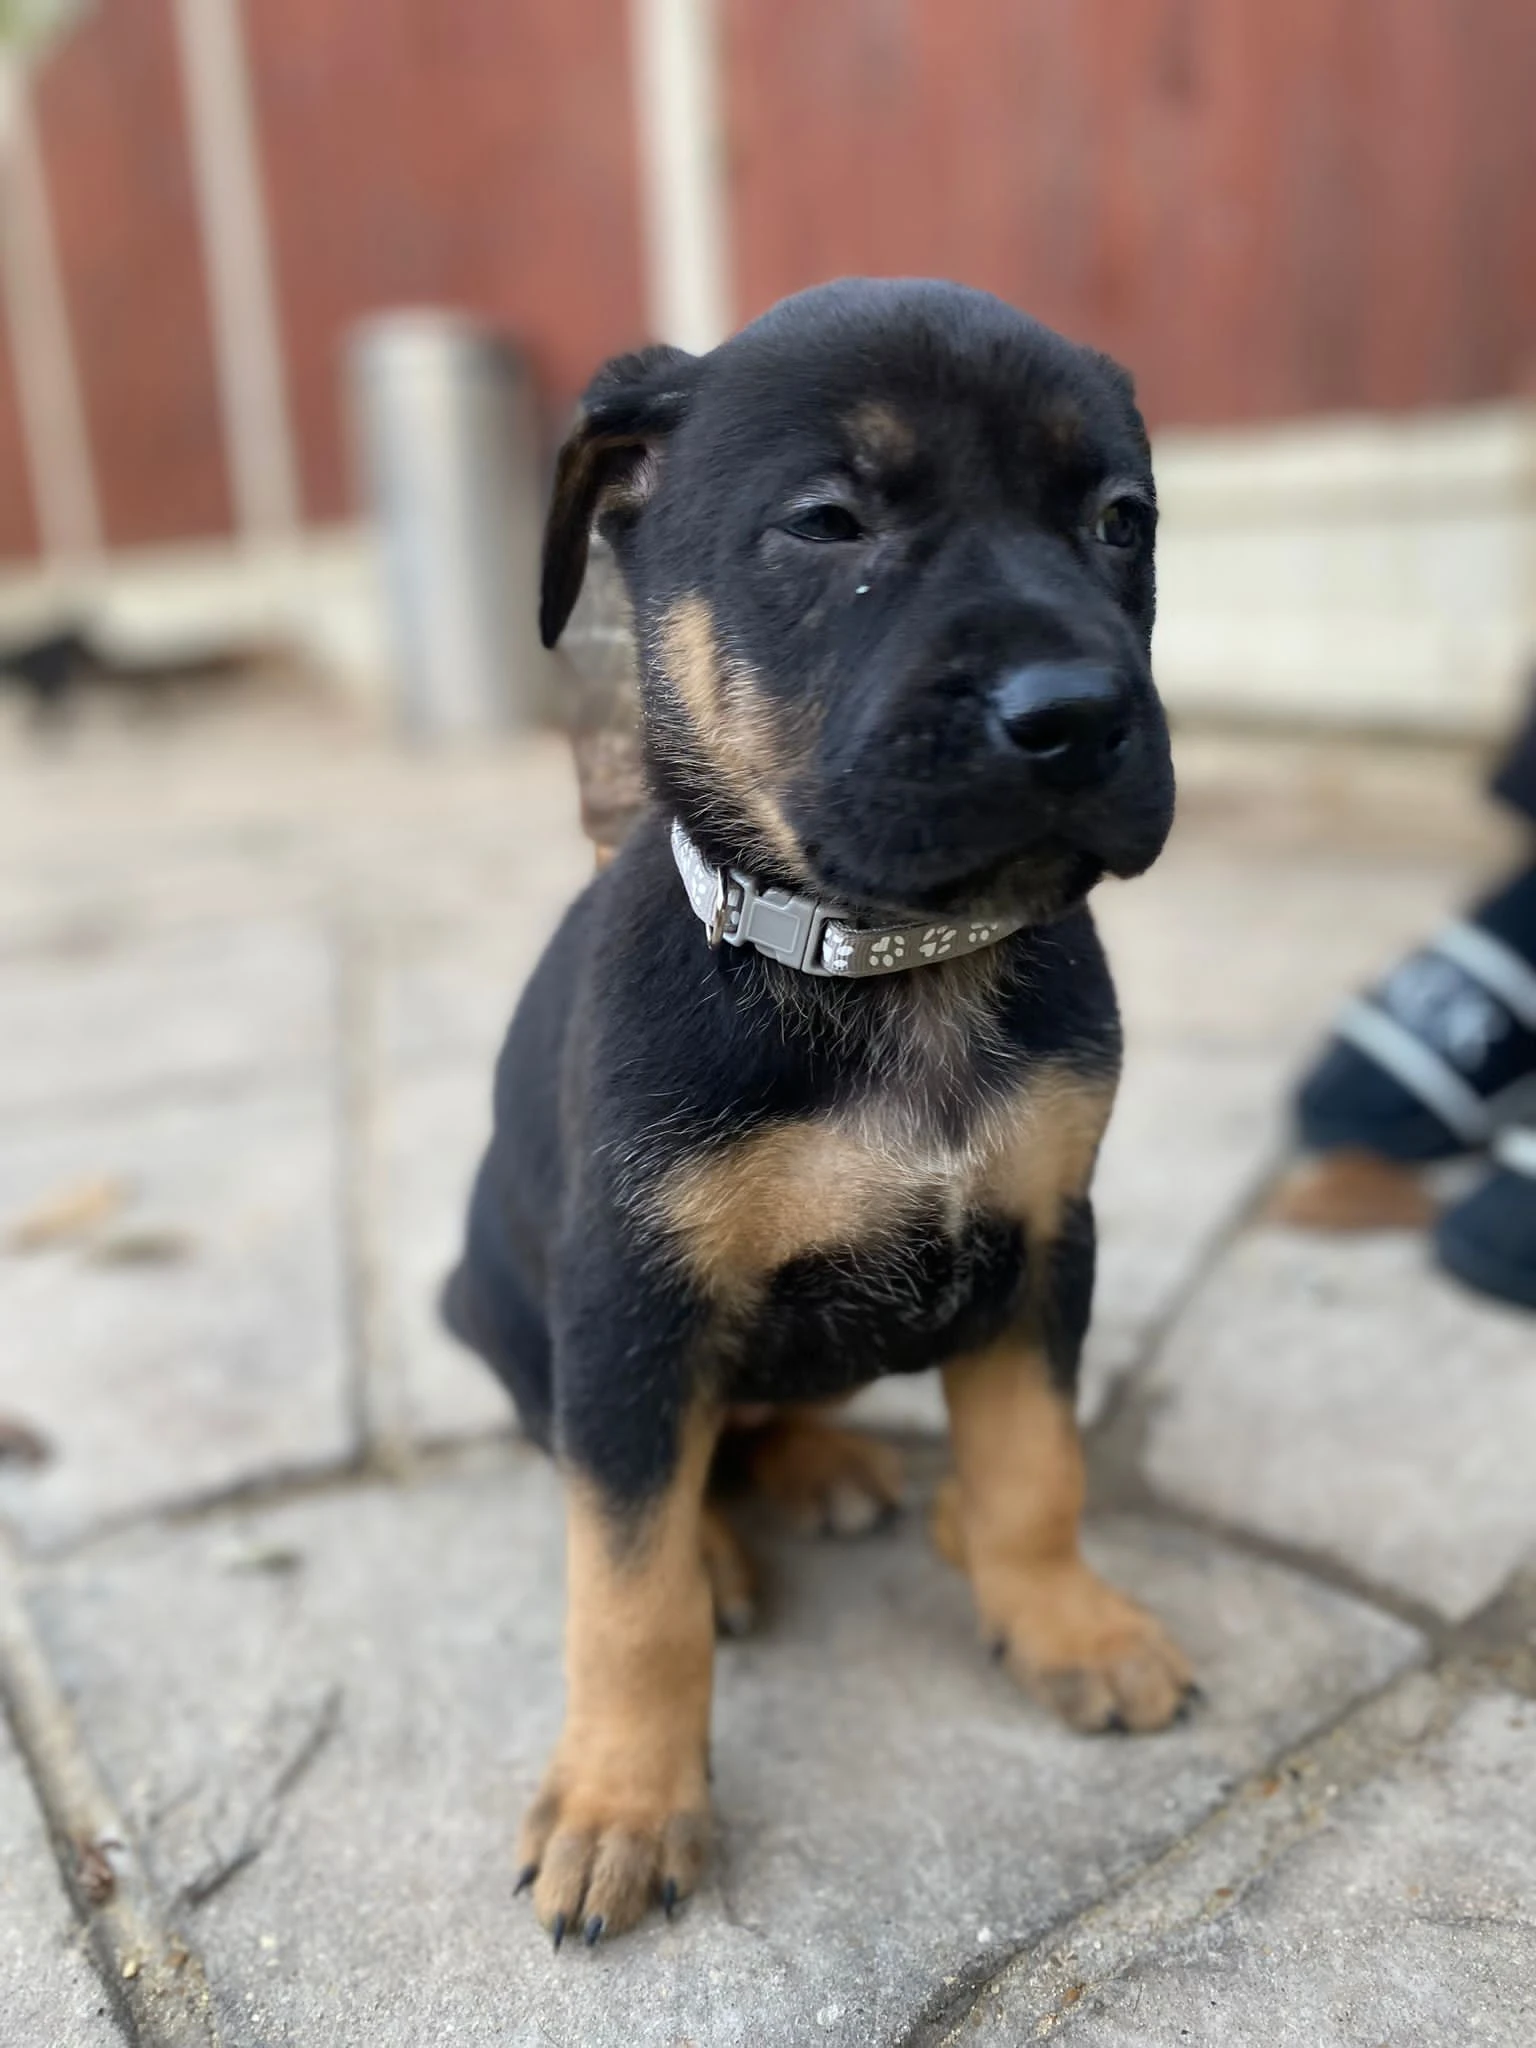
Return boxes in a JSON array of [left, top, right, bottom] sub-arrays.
[[1145, 1229, 1536, 1620]]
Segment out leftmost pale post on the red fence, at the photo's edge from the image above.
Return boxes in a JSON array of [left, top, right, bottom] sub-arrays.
[[0, 59, 100, 569]]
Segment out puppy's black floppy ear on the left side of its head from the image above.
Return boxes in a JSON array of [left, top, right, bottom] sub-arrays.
[[539, 346, 698, 647]]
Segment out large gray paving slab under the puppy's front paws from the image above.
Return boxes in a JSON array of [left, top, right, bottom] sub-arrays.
[[35, 1446, 1419, 2048]]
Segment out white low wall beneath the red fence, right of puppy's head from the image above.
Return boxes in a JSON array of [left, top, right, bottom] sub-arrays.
[[1155, 401, 1536, 735]]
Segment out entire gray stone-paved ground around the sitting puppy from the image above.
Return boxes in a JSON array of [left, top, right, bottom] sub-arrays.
[[0, 700, 1536, 2048]]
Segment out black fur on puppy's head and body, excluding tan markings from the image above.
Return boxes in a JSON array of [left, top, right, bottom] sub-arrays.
[[446, 283, 1171, 1507]]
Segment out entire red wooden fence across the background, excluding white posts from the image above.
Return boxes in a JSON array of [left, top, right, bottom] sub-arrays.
[[0, 0, 1536, 555]]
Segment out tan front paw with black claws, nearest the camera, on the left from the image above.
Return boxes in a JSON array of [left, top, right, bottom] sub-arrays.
[[518, 1761, 709, 1948]]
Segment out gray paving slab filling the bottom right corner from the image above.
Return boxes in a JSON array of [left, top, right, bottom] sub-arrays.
[[987, 1694, 1536, 2048]]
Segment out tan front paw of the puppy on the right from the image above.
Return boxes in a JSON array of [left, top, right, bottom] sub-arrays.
[[991, 1559, 1196, 1735]]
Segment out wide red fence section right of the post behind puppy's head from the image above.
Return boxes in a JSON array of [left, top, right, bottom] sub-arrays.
[[725, 0, 1536, 422]]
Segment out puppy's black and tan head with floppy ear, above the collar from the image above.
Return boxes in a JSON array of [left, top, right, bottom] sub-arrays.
[[543, 281, 1174, 918]]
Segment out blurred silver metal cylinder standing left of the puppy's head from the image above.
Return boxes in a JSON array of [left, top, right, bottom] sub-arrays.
[[348, 311, 557, 735]]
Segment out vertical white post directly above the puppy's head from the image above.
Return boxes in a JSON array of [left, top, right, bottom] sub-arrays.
[[631, 0, 731, 352]]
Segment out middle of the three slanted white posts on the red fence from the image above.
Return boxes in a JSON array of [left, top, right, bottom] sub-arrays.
[[176, 0, 299, 541]]
